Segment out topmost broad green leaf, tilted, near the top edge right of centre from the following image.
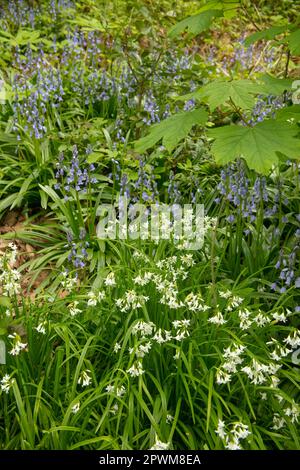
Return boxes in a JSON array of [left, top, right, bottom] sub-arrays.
[[169, 10, 223, 38]]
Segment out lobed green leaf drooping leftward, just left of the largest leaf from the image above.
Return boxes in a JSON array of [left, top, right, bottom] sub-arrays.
[[135, 108, 208, 153]]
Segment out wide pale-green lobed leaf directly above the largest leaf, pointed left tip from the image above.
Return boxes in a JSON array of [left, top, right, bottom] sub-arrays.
[[184, 79, 260, 111]]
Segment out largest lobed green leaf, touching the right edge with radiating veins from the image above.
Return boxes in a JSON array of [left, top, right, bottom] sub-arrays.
[[208, 120, 300, 173]]
